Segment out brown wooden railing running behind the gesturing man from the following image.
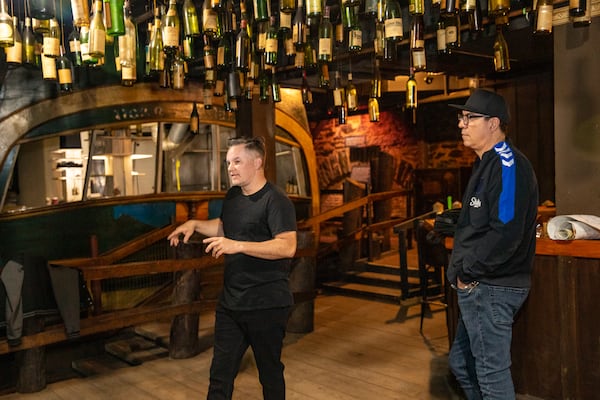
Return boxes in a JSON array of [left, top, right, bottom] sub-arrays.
[[0, 191, 410, 354]]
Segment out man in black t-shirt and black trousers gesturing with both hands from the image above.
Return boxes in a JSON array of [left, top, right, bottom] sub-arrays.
[[167, 138, 296, 400]]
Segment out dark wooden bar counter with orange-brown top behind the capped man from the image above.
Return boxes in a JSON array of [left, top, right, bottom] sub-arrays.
[[446, 239, 600, 400]]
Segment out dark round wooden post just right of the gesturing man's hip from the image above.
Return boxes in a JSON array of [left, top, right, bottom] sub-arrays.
[[287, 231, 317, 333]]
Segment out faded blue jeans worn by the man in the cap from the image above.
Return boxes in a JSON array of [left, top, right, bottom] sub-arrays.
[[448, 283, 529, 400]]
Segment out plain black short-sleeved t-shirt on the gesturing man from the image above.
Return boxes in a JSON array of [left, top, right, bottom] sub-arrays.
[[220, 183, 296, 310]]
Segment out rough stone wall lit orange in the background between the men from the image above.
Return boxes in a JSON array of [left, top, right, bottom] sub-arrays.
[[311, 111, 475, 217]]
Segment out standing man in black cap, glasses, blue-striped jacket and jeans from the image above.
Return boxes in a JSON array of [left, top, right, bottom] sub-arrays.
[[447, 89, 538, 400]]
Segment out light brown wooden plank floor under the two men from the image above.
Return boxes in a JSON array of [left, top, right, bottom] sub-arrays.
[[0, 295, 459, 400]]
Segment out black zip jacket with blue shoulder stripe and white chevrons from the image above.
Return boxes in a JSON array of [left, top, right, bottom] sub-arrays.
[[447, 141, 539, 287]]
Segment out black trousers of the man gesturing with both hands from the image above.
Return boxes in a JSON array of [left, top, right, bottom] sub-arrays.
[[207, 307, 290, 400]]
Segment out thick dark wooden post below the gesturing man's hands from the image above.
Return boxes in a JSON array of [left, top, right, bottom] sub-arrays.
[[169, 240, 204, 359]]
